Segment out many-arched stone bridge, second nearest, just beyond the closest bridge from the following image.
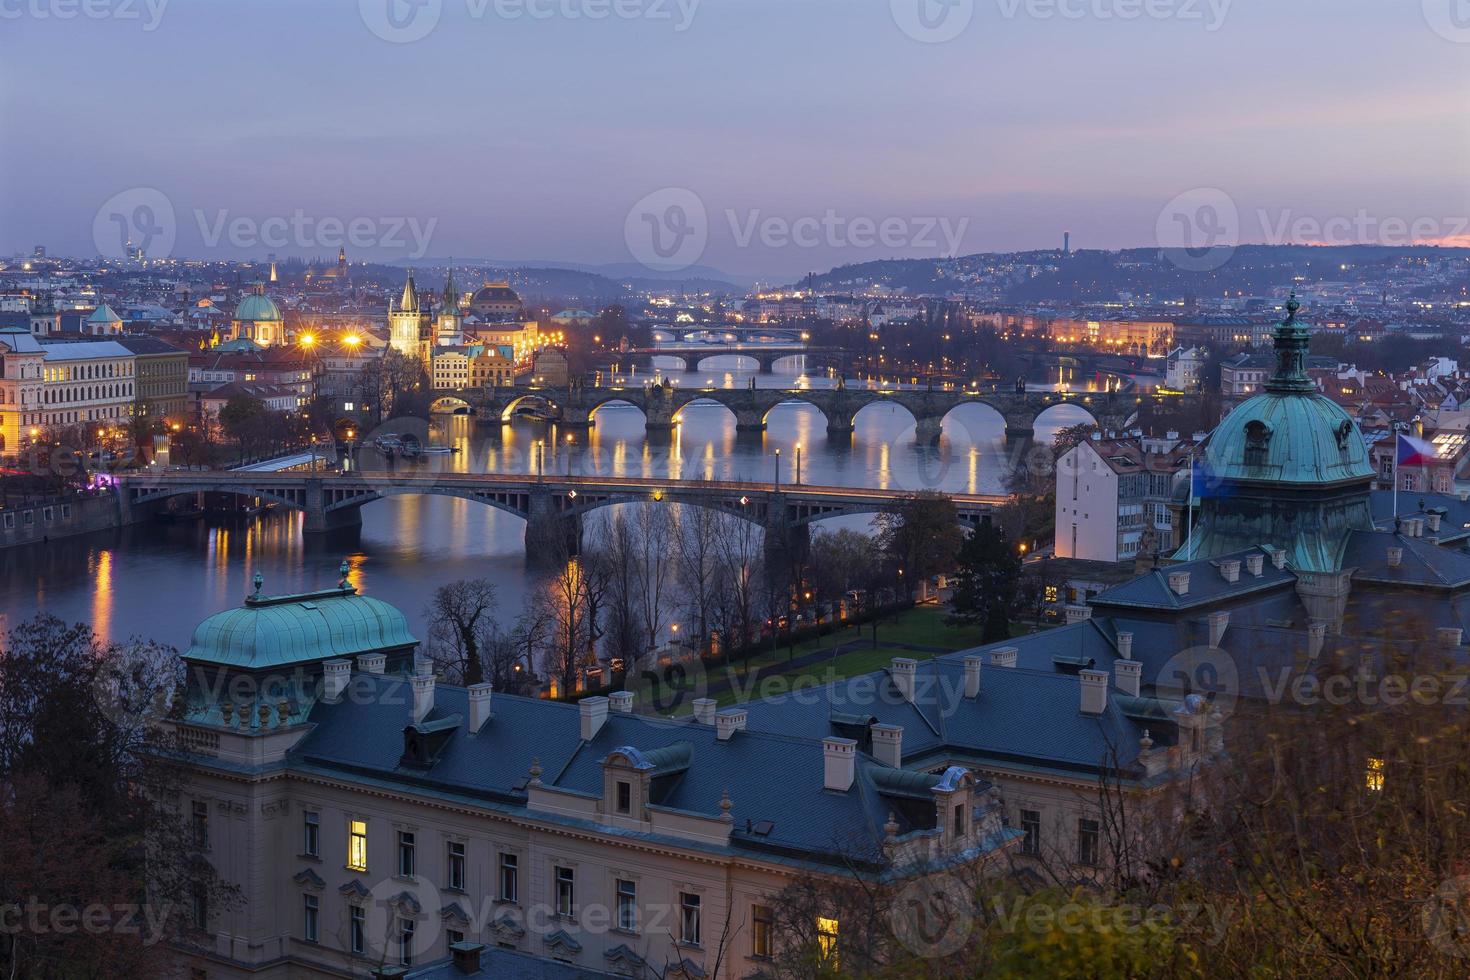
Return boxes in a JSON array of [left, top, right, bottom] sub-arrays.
[[435, 382, 1161, 445]]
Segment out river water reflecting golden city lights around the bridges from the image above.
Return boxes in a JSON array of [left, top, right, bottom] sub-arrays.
[[0, 357, 1089, 649]]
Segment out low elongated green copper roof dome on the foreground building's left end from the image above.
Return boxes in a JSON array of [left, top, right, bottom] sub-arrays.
[[184, 577, 419, 670]]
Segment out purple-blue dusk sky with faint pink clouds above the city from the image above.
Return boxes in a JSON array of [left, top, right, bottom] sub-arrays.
[[0, 0, 1470, 279]]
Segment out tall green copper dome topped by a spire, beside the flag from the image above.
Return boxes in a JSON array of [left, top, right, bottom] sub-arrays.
[[1205, 295, 1374, 486]]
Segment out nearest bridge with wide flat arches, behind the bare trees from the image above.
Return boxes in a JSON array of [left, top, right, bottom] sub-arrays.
[[116, 470, 1005, 563]]
